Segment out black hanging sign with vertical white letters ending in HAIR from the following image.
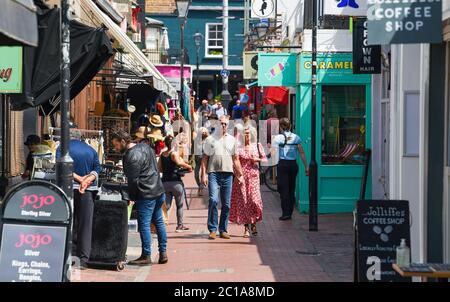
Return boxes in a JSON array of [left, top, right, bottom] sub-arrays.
[[353, 18, 381, 74]]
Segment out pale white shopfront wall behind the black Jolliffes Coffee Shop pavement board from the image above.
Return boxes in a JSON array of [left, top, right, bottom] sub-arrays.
[[390, 44, 429, 261]]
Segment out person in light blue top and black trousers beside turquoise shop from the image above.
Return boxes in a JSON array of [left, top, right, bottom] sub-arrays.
[[272, 118, 309, 220]]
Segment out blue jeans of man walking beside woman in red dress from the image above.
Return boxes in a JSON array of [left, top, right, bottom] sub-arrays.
[[208, 172, 233, 233]]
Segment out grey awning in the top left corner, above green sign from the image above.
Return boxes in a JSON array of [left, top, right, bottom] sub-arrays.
[[0, 0, 38, 46]]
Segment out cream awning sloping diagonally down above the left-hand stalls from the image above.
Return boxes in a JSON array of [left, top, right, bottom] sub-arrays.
[[78, 0, 177, 98]]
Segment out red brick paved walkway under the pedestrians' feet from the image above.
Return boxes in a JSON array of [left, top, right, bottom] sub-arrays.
[[74, 176, 353, 282]]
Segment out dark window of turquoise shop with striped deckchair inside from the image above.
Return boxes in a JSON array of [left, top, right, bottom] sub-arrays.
[[322, 85, 366, 165]]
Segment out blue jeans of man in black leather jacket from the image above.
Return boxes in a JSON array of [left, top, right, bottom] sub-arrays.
[[136, 193, 167, 256]]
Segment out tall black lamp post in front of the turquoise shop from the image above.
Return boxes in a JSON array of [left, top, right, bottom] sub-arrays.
[[309, 0, 318, 231]]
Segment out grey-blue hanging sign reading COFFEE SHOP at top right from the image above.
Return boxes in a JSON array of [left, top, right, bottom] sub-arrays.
[[367, 0, 442, 45]]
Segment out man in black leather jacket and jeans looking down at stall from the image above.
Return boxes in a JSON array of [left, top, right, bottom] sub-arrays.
[[112, 130, 168, 265]]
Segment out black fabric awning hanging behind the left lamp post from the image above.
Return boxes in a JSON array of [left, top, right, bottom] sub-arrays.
[[11, 2, 113, 115]]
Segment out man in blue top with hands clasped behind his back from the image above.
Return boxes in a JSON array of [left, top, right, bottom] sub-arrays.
[[56, 129, 101, 269]]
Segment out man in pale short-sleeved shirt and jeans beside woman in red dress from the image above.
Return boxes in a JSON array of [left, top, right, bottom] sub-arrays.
[[201, 116, 244, 239]]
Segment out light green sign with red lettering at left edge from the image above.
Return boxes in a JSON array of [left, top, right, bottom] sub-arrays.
[[0, 46, 22, 93]]
